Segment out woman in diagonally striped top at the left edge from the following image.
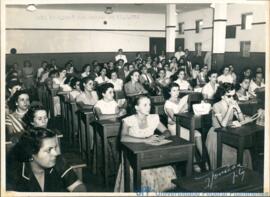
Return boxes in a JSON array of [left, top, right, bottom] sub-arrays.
[[6, 90, 30, 138]]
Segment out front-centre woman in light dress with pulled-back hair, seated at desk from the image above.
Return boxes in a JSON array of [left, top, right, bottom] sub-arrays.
[[114, 95, 176, 192]]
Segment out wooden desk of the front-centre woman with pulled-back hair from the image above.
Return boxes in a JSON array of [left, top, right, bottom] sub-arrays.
[[122, 136, 194, 192]]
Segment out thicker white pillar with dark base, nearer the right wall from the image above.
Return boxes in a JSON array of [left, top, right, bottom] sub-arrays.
[[212, 3, 227, 70]]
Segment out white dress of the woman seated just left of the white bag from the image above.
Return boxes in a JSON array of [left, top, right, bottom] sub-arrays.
[[164, 95, 201, 140]]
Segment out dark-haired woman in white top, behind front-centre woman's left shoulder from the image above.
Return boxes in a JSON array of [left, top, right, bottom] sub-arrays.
[[94, 83, 126, 120]]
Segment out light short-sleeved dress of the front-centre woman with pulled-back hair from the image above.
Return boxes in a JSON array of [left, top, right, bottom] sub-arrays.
[[114, 114, 176, 192]]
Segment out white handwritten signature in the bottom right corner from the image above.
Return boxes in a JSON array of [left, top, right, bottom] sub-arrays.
[[195, 164, 245, 190]]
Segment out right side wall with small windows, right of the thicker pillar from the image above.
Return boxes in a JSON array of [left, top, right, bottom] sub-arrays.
[[224, 4, 267, 74]]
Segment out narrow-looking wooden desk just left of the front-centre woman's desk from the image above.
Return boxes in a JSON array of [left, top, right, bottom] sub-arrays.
[[94, 120, 121, 187]]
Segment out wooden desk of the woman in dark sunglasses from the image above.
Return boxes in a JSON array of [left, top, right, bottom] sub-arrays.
[[215, 123, 264, 167]]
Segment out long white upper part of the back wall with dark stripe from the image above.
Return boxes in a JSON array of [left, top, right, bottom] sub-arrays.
[[6, 6, 165, 53]]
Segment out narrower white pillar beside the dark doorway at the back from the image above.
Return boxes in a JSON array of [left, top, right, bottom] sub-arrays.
[[166, 4, 177, 57]]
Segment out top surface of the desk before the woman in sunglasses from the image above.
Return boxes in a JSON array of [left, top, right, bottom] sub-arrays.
[[215, 122, 264, 137]]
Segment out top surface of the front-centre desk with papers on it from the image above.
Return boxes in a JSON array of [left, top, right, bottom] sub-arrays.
[[122, 136, 194, 154]]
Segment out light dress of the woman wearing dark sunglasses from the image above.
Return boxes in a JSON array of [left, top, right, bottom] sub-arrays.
[[206, 101, 252, 169]]
